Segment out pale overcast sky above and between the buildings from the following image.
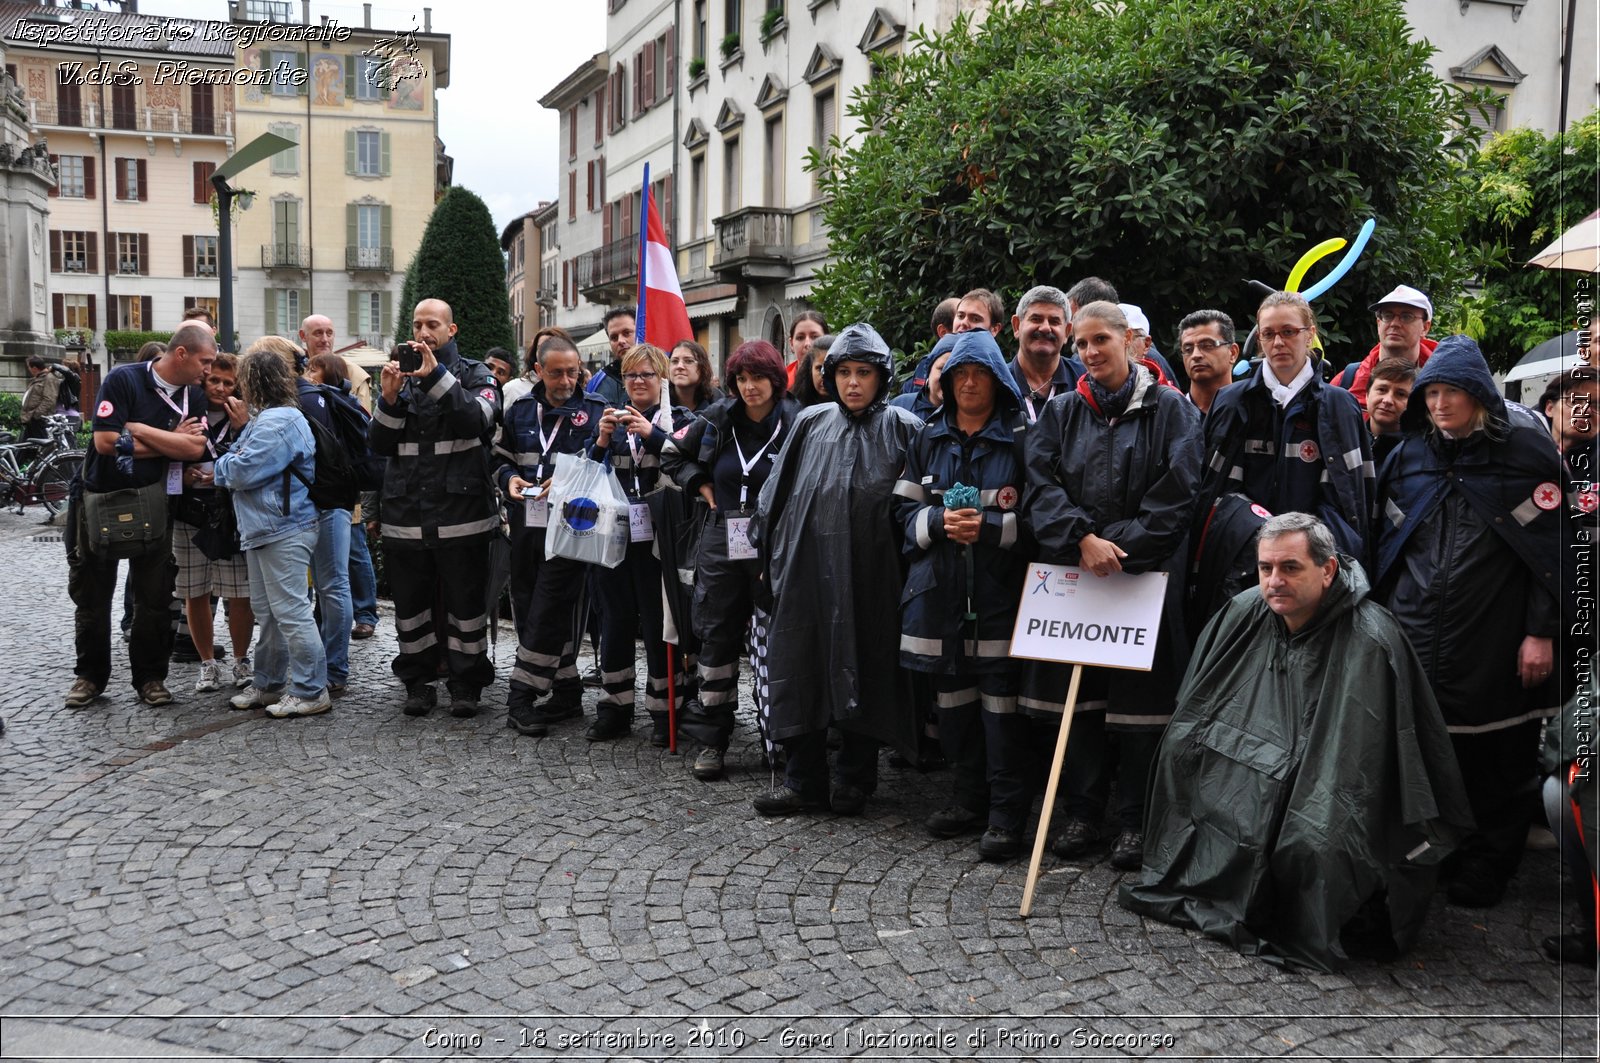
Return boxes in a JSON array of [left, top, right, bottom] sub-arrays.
[[139, 0, 605, 229]]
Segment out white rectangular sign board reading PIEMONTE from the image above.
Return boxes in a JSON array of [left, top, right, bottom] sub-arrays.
[[1011, 564, 1166, 672]]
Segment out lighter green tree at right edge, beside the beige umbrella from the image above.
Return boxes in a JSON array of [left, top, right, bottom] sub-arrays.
[[1450, 110, 1600, 368]]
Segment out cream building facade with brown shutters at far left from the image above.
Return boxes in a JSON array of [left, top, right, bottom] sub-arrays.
[[0, 3, 237, 347]]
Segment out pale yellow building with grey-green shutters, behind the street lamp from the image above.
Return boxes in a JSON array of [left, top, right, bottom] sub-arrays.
[[230, 3, 450, 347]]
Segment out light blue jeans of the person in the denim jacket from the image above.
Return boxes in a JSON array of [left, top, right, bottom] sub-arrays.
[[245, 528, 328, 698]]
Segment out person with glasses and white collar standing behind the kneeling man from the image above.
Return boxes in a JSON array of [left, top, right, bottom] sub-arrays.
[[1197, 291, 1376, 569]]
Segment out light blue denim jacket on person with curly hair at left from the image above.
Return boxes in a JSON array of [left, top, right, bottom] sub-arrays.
[[216, 407, 317, 551]]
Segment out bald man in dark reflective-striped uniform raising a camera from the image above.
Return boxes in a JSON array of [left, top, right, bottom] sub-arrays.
[[370, 299, 499, 717]]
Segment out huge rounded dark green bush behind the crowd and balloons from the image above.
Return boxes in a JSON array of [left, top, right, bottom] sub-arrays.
[[813, 0, 1475, 363]]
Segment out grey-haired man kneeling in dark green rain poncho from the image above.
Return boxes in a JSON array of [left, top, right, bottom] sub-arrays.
[[1122, 512, 1472, 970]]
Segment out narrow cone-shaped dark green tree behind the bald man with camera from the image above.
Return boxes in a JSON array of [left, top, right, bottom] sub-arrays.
[[400, 187, 515, 359]]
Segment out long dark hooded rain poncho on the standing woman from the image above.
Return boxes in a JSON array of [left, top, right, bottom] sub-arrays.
[[752, 325, 922, 749]]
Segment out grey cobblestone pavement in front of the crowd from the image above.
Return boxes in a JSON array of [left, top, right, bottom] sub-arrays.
[[0, 511, 1595, 1060]]
